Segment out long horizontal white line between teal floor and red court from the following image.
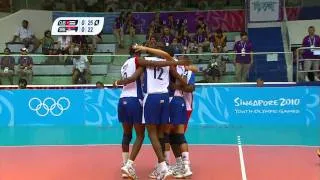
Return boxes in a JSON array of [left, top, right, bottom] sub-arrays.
[[0, 144, 320, 148]]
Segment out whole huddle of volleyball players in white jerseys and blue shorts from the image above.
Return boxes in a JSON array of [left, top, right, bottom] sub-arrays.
[[114, 45, 196, 180]]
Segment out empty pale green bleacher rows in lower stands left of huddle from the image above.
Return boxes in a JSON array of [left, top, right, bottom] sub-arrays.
[[2, 53, 127, 85]]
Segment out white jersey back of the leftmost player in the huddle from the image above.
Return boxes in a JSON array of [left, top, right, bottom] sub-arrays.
[[120, 57, 142, 99]]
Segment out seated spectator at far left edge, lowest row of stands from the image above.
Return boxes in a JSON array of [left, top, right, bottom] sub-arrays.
[[0, 48, 15, 85]]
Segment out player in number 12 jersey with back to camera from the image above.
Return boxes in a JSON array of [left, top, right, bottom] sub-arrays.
[[143, 46, 190, 179]]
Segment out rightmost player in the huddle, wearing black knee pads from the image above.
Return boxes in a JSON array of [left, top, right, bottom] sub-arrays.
[[149, 51, 197, 179]]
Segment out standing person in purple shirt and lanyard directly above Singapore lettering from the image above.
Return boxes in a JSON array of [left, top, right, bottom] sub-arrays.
[[234, 32, 253, 82]]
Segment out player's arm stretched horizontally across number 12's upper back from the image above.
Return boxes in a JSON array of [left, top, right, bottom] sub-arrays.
[[137, 57, 191, 67]]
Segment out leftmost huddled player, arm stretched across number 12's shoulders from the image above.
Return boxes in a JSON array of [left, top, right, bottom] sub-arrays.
[[114, 45, 187, 179]]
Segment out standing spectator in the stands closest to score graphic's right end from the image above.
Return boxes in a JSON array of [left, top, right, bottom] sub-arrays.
[[113, 11, 125, 48]]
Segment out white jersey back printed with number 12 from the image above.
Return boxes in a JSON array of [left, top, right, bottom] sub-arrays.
[[144, 57, 170, 94]]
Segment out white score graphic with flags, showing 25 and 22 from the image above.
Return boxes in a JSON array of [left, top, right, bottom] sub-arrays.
[[51, 17, 104, 36]]
